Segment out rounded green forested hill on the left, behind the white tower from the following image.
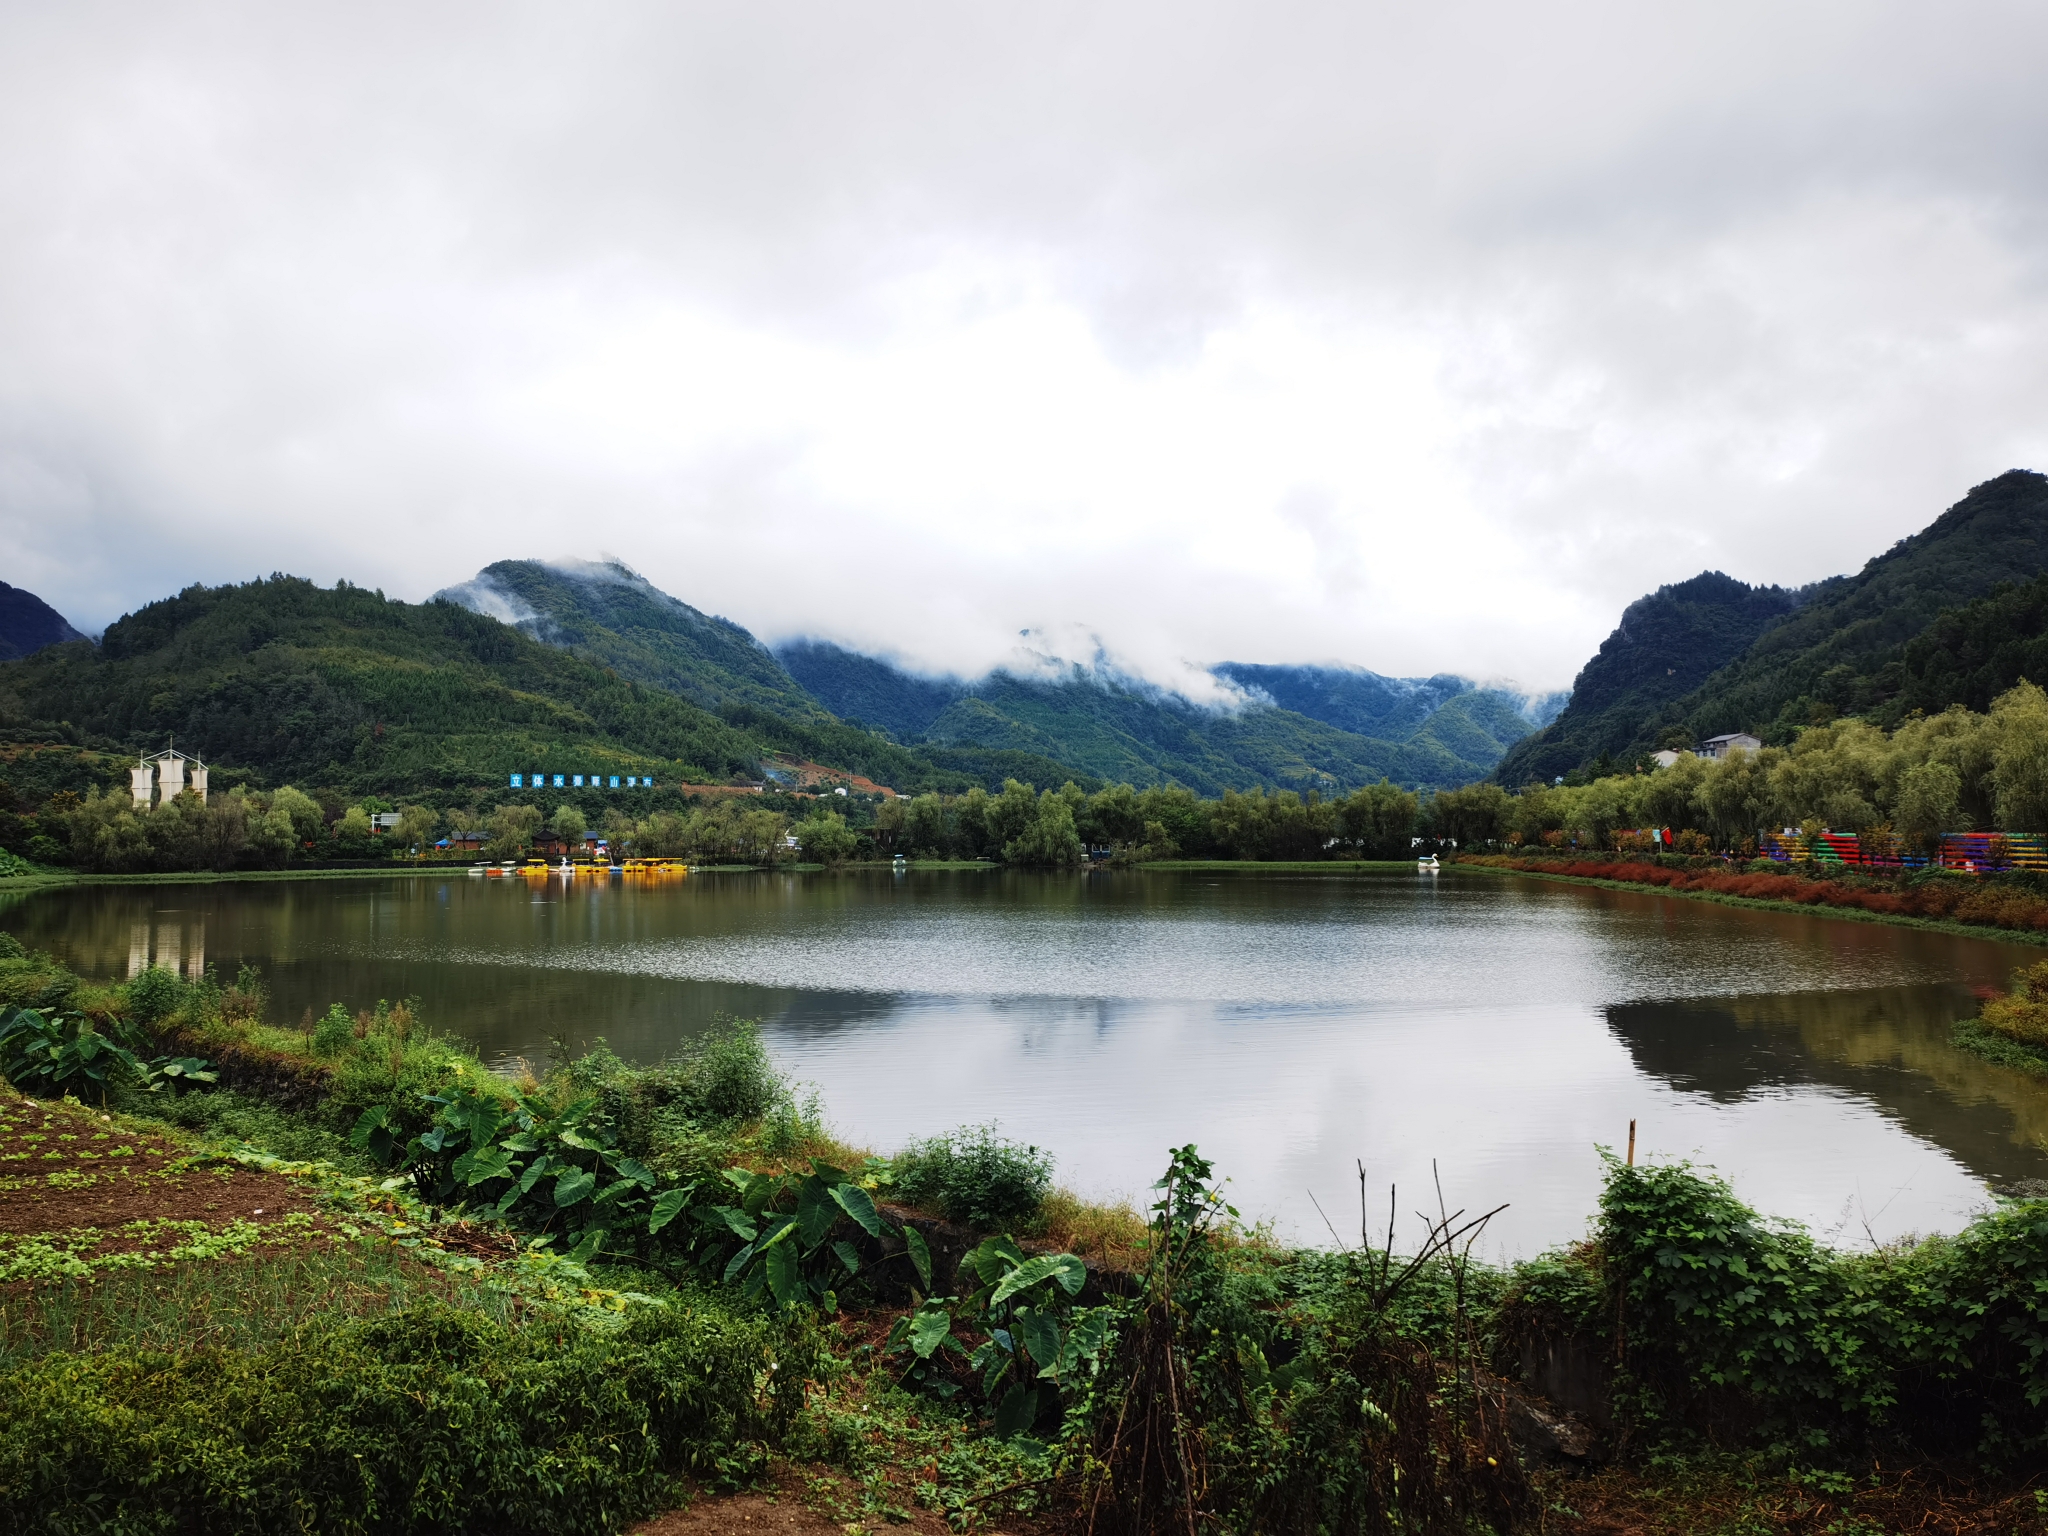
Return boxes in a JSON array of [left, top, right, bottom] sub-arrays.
[[0, 575, 946, 795]]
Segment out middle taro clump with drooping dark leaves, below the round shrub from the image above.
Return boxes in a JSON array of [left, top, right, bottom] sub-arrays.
[[694, 1157, 932, 1311]]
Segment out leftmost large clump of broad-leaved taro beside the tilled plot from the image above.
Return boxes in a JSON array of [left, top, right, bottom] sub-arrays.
[[348, 1087, 675, 1257]]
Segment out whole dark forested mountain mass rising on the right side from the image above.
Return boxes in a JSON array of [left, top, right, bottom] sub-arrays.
[[1497, 469, 2048, 784]]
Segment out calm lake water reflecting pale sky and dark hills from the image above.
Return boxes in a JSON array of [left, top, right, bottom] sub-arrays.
[[0, 870, 2048, 1253]]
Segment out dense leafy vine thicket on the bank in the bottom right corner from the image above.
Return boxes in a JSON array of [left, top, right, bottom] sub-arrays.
[[1589, 1161, 2048, 1466]]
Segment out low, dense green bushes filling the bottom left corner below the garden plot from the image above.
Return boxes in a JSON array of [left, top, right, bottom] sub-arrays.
[[0, 1300, 817, 1536]]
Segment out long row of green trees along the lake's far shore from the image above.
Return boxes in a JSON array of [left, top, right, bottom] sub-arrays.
[[12, 682, 2048, 870]]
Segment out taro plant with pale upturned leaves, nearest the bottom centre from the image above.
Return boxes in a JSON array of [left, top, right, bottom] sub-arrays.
[[883, 1229, 1114, 1440]]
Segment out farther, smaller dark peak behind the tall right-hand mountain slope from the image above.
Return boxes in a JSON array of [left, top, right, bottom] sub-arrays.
[[1495, 571, 1798, 784]]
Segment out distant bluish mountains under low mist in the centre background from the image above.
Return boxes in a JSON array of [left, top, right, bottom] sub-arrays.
[[776, 641, 1532, 795]]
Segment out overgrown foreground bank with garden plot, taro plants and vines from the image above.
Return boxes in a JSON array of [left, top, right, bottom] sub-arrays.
[[0, 946, 2048, 1536]]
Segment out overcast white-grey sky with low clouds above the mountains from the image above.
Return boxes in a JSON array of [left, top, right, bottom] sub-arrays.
[[0, 0, 2048, 688]]
